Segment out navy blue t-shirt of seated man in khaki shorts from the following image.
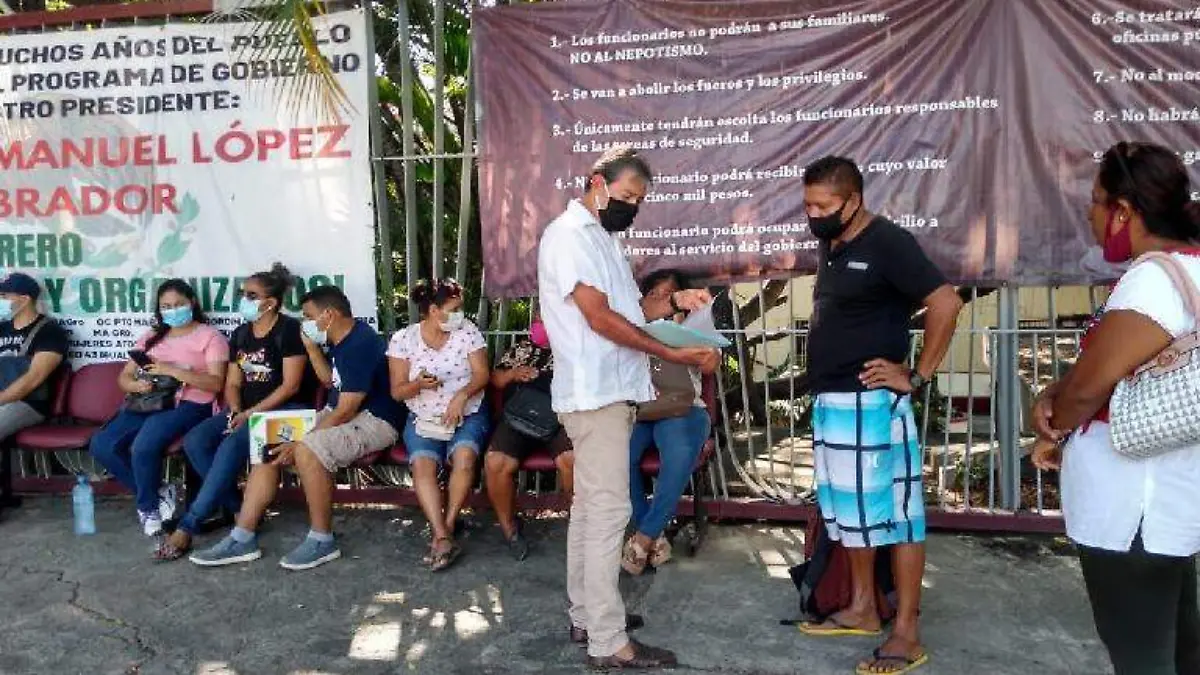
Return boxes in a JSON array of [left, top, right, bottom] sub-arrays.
[[329, 321, 401, 430]]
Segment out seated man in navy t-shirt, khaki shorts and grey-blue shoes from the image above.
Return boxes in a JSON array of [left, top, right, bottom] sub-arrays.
[[191, 286, 402, 569]]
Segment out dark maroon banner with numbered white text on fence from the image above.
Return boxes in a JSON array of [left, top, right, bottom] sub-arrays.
[[474, 0, 1200, 297]]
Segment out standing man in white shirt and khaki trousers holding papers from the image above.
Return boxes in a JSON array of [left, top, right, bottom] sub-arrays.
[[538, 148, 718, 669]]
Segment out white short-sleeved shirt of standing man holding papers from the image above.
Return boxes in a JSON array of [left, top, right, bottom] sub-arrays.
[[538, 199, 654, 413]]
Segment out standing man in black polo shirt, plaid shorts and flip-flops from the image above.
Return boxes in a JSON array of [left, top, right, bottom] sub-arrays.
[[802, 157, 962, 673]]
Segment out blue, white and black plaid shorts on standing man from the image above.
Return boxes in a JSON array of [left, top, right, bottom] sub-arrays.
[[812, 390, 925, 548]]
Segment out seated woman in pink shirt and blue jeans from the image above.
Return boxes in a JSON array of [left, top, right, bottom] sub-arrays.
[[90, 279, 229, 537]]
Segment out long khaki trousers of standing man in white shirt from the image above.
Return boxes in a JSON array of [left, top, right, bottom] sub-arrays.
[[559, 404, 636, 657]]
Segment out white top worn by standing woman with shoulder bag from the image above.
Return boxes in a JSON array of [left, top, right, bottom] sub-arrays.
[[1061, 255, 1200, 556]]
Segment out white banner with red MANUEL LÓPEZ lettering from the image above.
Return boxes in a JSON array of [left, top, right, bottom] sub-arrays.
[[0, 11, 376, 365]]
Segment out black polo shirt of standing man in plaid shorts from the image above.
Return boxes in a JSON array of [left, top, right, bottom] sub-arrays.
[[808, 216, 946, 394]]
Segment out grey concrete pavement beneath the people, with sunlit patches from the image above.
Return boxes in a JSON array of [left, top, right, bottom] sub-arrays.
[[0, 497, 1110, 675]]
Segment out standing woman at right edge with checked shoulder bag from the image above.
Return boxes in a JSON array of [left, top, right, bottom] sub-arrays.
[[1033, 143, 1200, 675]]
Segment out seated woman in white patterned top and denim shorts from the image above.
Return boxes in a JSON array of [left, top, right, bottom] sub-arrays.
[[388, 279, 491, 572]]
